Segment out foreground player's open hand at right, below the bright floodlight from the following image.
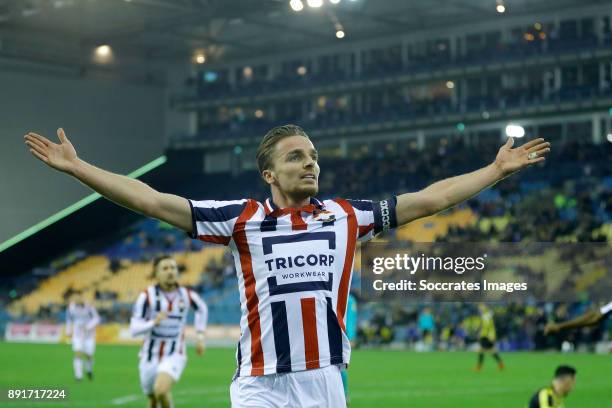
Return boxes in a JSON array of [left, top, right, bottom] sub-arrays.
[[495, 137, 550, 177]]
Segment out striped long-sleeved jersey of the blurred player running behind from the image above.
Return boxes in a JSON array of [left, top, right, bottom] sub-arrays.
[[130, 285, 208, 361]]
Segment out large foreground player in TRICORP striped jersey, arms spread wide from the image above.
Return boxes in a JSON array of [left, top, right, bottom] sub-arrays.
[[25, 125, 550, 408]]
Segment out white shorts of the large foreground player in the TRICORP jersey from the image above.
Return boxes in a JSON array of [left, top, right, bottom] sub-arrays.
[[230, 365, 346, 408]]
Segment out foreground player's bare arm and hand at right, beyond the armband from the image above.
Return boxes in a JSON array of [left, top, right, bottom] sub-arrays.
[[396, 138, 550, 225]]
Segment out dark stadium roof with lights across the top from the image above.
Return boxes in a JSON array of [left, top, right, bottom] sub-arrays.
[[0, 0, 608, 76]]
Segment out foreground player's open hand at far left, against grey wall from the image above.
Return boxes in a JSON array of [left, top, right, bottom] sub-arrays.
[[24, 128, 78, 173]]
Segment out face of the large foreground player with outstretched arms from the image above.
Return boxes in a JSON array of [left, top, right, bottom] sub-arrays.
[[264, 136, 320, 197]]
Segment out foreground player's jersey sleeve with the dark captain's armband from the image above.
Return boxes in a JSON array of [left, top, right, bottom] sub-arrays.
[[346, 197, 397, 242]]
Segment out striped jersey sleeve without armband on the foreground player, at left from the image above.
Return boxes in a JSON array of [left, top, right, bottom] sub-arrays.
[[188, 199, 248, 245]]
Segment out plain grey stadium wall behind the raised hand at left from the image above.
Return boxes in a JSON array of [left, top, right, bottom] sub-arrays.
[[0, 71, 166, 242]]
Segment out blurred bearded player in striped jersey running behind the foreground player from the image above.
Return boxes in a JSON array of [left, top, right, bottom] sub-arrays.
[[130, 255, 208, 408]]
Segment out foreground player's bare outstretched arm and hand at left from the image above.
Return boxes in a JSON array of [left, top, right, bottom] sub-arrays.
[[25, 129, 193, 233]]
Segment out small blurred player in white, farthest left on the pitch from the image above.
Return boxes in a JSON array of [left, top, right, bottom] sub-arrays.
[[66, 291, 100, 381]]
